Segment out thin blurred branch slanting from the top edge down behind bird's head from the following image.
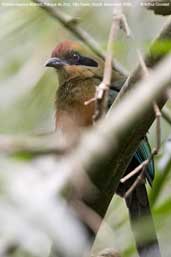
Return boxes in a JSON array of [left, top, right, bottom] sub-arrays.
[[32, 0, 128, 77]]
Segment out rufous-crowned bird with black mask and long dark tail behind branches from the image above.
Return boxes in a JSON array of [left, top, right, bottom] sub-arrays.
[[45, 40, 161, 257]]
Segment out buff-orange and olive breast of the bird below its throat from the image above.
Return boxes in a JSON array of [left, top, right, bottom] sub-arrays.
[[56, 78, 99, 138]]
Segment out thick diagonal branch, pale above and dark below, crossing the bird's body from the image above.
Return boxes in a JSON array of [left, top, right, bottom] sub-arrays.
[[66, 55, 171, 216]]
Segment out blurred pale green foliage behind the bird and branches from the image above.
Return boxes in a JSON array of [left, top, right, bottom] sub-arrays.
[[0, 1, 171, 257]]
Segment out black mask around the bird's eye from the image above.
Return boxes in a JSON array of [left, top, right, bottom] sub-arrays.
[[65, 52, 98, 67]]
